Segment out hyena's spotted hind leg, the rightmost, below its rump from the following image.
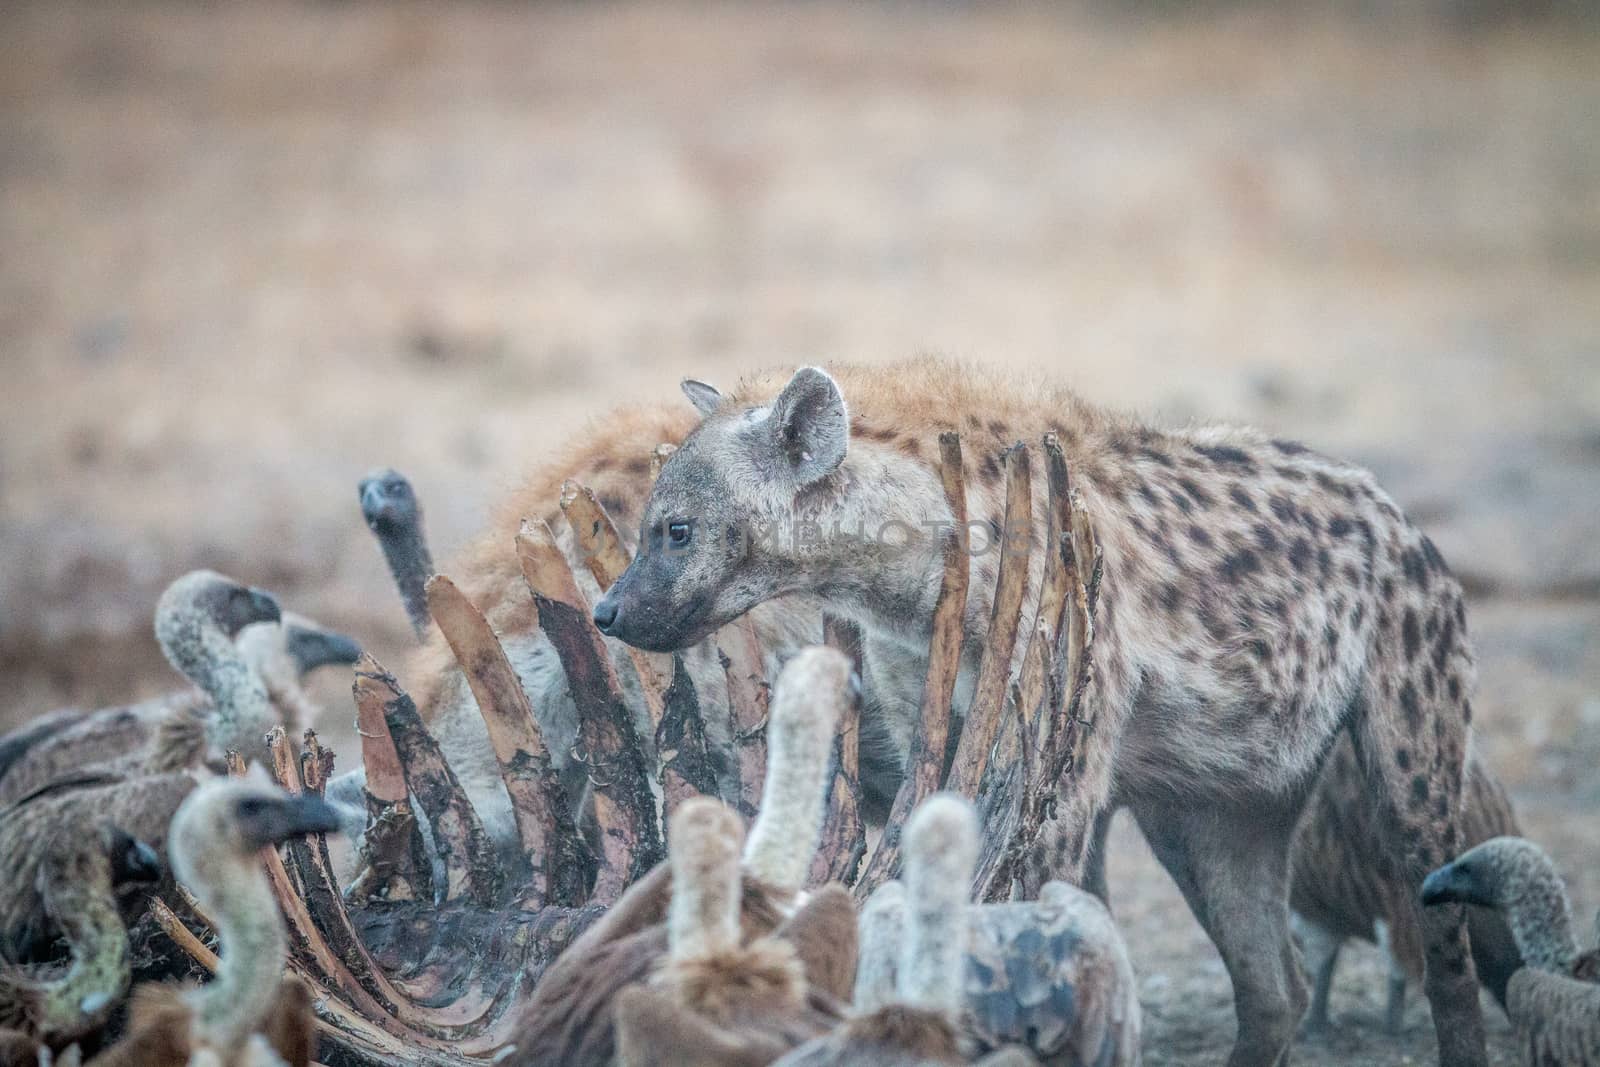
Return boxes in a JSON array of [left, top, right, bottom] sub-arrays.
[[1352, 575, 1488, 1067]]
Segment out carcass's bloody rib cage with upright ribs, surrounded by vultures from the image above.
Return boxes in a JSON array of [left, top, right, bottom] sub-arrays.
[[147, 434, 1099, 1065]]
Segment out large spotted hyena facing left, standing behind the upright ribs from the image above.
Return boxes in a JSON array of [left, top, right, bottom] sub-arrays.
[[595, 358, 1485, 1065]]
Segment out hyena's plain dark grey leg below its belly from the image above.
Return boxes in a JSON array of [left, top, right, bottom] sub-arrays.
[[1133, 801, 1309, 1067]]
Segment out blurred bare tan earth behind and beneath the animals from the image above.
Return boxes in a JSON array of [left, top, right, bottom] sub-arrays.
[[0, 3, 1600, 1065]]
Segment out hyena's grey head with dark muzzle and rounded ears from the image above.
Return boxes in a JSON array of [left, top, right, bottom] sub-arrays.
[[595, 366, 850, 651]]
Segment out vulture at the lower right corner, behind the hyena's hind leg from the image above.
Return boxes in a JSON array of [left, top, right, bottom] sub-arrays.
[[1422, 837, 1600, 1067]]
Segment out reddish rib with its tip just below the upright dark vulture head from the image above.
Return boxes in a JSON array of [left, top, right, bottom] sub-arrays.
[[427, 574, 590, 909]]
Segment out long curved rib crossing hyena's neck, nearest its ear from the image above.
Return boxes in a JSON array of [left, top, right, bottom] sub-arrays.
[[856, 434, 968, 899]]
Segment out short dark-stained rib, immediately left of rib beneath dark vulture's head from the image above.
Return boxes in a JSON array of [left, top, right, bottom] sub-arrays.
[[354, 654, 501, 905]]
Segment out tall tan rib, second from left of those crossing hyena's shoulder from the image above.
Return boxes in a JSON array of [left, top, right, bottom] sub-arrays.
[[947, 442, 1034, 797]]
